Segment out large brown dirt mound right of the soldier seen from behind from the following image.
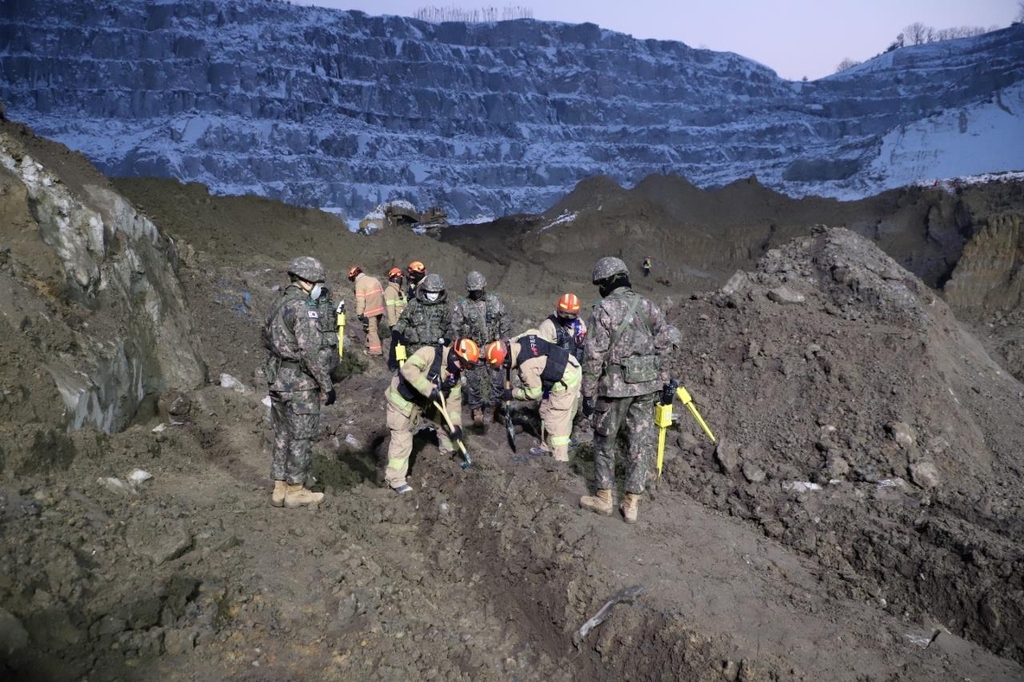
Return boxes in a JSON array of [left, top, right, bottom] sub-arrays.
[[666, 229, 1024, 660]]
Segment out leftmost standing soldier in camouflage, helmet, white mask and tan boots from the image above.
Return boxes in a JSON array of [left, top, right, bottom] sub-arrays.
[[263, 257, 337, 509]]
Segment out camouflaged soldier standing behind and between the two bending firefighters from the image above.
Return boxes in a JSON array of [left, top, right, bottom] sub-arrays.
[[452, 270, 512, 426]]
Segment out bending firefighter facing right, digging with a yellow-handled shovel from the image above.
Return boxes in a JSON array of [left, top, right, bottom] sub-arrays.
[[384, 339, 480, 494]]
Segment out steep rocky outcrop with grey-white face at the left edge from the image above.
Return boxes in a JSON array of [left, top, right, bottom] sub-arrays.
[[0, 127, 205, 470]]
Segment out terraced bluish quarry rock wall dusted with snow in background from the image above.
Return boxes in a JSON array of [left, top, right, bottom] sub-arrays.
[[0, 0, 1024, 222]]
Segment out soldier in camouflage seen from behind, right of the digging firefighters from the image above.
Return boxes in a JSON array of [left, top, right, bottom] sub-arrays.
[[580, 257, 671, 523]]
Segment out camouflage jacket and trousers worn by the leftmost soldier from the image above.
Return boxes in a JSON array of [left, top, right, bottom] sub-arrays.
[[263, 284, 337, 485]]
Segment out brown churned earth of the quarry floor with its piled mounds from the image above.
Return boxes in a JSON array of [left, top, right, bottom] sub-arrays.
[[0, 119, 1024, 680]]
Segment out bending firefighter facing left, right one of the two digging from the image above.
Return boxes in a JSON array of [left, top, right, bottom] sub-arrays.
[[484, 329, 583, 462]]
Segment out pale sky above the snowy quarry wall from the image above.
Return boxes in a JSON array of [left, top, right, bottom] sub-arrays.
[[292, 0, 1019, 80]]
